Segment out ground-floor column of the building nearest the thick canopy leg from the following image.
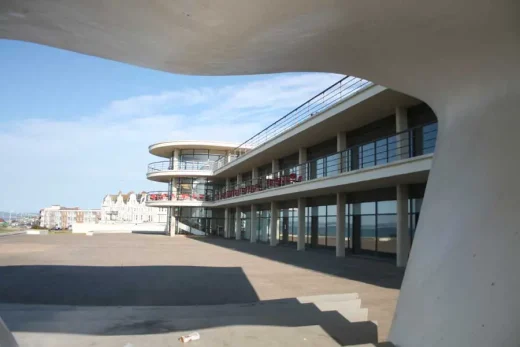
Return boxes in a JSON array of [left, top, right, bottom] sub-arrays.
[[397, 184, 411, 267]]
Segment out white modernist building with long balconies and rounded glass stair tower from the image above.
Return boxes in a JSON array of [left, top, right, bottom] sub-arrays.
[[147, 80, 437, 266]]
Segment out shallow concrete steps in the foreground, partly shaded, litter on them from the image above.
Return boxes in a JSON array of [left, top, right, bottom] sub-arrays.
[[0, 293, 388, 347]]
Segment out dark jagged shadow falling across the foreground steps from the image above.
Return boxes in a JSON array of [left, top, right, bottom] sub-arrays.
[[0, 299, 378, 345]]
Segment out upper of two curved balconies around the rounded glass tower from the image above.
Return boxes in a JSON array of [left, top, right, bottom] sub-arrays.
[[146, 160, 213, 182]]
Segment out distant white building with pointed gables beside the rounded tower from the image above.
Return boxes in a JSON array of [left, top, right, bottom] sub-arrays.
[[101, 192, 167, 223]]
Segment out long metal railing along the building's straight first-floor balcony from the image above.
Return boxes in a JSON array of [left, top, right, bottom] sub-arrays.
[[214, 123, 437, 201]]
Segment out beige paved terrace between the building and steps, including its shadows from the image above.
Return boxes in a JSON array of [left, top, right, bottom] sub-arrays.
[[0, 234, 403, 341]]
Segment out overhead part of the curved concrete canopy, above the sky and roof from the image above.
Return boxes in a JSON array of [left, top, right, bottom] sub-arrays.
[[0, 0, 520, 107]]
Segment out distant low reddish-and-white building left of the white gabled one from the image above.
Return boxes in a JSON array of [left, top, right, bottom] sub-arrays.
[[40, 205, 101, 229]]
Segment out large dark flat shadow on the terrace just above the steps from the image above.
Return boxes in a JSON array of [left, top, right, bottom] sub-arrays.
[[0, 265, 258, 306]]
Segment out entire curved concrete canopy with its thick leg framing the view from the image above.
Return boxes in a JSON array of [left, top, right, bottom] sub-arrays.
[[0, 0, 520, 347]]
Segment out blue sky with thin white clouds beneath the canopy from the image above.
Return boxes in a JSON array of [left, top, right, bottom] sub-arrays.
[[0, 40, 342, 212]]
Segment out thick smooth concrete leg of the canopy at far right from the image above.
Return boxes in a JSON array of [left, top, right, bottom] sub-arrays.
[[390, 96, 520, 347]]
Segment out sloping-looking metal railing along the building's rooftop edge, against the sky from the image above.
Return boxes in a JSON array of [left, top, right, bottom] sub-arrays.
[[213, 76, 373, 170]]
